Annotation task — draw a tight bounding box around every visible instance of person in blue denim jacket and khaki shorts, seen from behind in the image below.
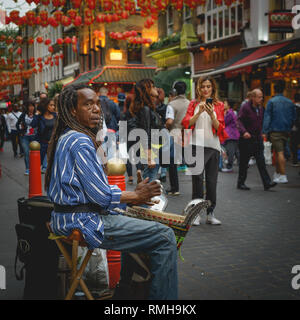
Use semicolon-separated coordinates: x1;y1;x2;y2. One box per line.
263;80;296;183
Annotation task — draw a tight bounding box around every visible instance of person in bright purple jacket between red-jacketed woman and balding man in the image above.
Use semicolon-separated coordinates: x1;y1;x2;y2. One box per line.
222;100;240;172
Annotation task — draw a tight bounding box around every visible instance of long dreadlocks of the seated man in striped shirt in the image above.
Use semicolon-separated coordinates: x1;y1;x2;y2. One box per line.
45;84;103;190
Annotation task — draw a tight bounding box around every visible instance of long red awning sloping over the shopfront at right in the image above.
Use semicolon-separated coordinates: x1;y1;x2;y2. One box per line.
194;40;299;77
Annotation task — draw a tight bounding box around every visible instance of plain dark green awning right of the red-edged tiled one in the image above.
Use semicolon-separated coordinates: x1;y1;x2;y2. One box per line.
154;67;191;96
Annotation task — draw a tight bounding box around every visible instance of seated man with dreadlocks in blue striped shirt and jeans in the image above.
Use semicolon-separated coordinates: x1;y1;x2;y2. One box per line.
45;85;177;299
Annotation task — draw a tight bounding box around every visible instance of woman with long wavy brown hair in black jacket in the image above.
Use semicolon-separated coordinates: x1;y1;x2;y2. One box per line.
129;79;164;181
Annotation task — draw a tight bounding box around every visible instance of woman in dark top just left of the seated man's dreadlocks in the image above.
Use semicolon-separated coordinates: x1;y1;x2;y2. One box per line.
31;98;56;173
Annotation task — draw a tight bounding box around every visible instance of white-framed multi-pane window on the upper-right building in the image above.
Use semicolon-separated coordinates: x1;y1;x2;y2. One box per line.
205;0;243;42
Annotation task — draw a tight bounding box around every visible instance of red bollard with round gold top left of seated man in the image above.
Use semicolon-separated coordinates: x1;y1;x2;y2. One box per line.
28;141;43;198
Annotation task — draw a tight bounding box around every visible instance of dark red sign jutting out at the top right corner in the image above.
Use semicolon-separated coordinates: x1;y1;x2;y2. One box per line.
269;12;295;33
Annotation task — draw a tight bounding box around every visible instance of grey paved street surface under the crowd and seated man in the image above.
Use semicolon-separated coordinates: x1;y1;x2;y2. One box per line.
0;143;300;300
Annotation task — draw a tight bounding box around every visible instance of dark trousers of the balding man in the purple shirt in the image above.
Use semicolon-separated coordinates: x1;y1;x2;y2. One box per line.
238;138;271;187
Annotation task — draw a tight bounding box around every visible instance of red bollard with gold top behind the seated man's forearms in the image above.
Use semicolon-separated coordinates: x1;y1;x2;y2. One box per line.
106;158;126;289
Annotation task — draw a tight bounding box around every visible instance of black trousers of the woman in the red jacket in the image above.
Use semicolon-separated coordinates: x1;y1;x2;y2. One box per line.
192;148;220;213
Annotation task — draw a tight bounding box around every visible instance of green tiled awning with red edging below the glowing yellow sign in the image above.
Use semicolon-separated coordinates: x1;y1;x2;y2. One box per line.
89;66;156;84
